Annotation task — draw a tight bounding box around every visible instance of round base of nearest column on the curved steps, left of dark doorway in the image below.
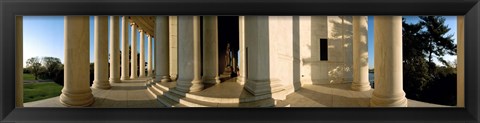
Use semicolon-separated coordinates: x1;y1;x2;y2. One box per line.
175;80;204;93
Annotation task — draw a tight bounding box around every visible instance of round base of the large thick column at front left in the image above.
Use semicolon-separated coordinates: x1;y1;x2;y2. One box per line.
60;88;95;107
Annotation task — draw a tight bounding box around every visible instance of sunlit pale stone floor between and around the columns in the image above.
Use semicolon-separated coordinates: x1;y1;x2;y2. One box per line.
24;79;450;108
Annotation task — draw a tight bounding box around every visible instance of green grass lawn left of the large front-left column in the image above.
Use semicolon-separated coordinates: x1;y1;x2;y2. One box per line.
23;82;63;103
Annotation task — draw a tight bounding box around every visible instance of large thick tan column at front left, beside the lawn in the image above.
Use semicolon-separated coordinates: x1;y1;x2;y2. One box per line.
60;16;94;106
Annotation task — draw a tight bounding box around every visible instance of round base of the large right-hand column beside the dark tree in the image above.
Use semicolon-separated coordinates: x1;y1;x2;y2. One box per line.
370;92;407;107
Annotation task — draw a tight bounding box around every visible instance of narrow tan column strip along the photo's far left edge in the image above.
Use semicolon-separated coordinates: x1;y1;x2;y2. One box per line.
15;16;23;107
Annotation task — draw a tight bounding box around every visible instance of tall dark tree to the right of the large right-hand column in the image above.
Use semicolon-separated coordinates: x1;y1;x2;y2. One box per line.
402;16;456;105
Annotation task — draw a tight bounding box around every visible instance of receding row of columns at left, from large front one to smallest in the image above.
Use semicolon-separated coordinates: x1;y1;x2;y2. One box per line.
60;16;158;106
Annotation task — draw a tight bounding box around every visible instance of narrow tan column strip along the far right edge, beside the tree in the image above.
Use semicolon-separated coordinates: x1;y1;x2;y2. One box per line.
457;16;465;107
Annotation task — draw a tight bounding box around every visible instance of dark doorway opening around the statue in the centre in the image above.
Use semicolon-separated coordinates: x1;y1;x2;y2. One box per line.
218;16;239;74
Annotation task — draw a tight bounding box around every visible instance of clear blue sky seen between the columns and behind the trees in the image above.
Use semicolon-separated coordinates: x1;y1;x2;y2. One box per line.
23;16;457;68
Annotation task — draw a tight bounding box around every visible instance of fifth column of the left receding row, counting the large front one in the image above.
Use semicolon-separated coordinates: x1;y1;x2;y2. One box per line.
130;23;138;79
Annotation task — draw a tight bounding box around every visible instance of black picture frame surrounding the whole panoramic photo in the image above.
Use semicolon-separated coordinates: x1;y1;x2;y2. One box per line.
0;0;480;122
